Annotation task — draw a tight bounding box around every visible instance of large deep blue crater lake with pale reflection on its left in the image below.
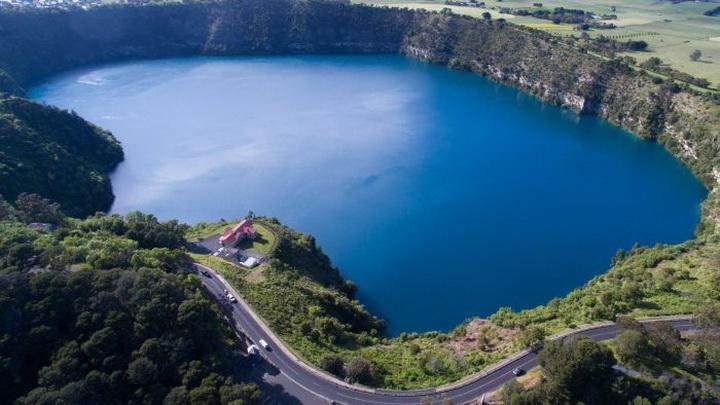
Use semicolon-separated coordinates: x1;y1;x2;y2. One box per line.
30;56;706;335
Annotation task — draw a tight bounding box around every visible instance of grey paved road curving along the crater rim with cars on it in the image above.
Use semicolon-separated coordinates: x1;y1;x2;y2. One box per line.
195;263;694;405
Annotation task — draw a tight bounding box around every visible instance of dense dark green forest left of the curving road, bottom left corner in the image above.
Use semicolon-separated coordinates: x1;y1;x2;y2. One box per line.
0;195;260;404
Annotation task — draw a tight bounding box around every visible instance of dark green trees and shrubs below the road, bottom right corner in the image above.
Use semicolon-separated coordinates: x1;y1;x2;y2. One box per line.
500;305;720;405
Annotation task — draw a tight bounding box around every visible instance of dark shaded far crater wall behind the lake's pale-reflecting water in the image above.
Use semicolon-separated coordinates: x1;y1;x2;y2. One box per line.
0;0;412;83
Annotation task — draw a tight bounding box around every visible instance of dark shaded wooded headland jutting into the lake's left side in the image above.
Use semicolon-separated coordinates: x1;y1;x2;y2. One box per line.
0;96;123;216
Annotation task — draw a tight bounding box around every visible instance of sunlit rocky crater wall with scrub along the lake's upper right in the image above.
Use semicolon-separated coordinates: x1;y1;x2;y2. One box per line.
401;13;720;188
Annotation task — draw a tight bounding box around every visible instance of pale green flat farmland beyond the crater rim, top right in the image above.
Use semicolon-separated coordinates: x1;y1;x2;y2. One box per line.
353;0;720;88
